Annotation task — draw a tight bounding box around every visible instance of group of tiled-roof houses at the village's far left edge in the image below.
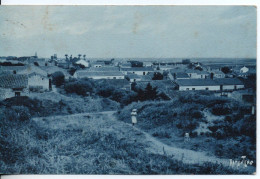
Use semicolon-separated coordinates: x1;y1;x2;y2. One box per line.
0;64;69;99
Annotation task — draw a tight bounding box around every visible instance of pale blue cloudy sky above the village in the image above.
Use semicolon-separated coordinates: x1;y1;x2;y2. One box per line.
0;6;256;58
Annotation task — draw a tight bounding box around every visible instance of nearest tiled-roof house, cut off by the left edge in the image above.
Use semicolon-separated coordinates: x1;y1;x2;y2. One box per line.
0;74;29;100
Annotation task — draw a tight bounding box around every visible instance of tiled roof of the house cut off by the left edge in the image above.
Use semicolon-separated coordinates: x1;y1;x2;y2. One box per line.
0;75;28;88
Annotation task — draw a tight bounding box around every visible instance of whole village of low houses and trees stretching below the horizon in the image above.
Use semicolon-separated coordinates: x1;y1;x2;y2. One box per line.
0;53;256;103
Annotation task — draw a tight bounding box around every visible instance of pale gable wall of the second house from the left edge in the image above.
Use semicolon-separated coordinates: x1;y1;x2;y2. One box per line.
28;75;49;90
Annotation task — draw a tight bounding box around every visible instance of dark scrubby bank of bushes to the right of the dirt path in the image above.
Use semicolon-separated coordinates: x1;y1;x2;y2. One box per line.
118;92;256;166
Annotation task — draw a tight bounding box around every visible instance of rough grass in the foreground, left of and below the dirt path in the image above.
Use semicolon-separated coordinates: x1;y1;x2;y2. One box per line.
0;107;252;174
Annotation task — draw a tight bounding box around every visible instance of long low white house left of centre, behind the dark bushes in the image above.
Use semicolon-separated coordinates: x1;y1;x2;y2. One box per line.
74;70;125;80
